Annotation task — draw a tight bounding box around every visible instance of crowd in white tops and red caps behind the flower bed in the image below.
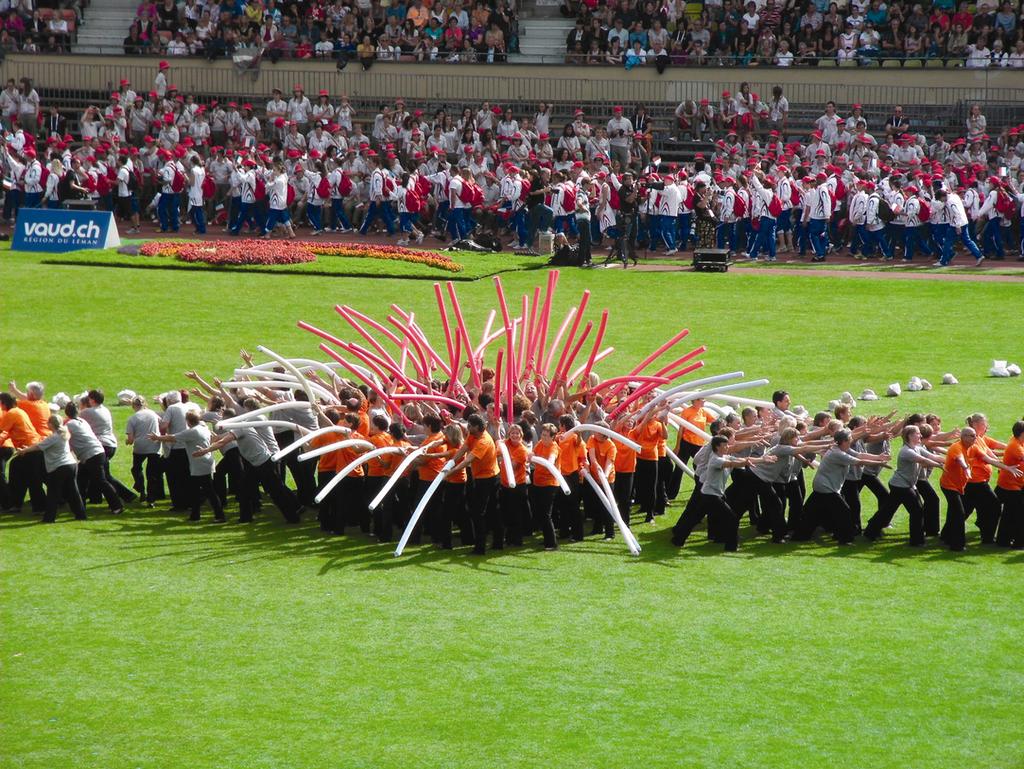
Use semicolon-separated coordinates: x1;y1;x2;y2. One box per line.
6;67;1024;266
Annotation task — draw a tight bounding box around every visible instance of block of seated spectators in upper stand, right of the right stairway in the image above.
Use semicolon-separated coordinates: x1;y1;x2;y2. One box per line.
562;0;1024;73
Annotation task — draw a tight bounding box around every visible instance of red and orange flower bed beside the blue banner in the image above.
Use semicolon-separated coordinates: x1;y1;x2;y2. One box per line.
138;240;462;272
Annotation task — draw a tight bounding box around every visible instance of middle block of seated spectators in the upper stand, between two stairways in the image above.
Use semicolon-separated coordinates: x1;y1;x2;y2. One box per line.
124;0;518;69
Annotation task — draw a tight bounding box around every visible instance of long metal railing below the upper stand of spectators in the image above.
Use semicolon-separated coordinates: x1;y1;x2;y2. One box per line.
0;54;1024;112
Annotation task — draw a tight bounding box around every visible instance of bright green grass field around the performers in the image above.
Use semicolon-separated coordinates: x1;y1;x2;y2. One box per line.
0;247;1024;769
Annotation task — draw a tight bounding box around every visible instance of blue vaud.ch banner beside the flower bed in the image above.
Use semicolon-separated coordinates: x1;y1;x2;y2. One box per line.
10;208;121;253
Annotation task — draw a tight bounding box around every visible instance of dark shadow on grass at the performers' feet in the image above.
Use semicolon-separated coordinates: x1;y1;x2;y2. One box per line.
0;506;1024;575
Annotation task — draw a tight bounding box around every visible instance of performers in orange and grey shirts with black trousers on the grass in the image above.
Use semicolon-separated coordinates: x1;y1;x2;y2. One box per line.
0;372;1024;554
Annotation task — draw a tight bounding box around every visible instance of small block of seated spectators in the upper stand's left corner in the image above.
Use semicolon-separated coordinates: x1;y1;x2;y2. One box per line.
0;0;88;53
